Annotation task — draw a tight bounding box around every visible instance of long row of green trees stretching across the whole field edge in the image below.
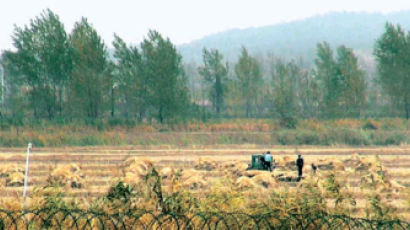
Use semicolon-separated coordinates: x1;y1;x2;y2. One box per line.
0;10;410;127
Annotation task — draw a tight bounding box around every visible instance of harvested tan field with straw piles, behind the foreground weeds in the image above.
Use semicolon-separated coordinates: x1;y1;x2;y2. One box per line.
0;146;410;219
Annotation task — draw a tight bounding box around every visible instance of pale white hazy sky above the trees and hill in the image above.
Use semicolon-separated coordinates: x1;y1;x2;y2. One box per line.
0;0;410;50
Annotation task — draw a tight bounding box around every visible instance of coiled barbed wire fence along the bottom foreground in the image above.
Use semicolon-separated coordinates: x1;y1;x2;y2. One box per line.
0;208;410;230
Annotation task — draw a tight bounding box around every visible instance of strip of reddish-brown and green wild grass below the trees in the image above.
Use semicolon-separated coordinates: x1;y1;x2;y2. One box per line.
0;118;410;147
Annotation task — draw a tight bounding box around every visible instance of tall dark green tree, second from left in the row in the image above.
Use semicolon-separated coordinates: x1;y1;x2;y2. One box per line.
70;18;111;118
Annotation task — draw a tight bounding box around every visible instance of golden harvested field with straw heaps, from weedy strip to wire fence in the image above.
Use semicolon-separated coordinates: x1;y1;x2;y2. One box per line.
0;145;410;220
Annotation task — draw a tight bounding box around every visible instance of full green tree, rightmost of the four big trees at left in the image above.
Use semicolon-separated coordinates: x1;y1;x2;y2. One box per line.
141;31;189;123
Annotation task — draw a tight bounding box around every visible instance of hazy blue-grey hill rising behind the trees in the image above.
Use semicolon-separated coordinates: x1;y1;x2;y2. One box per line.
179;11;410;62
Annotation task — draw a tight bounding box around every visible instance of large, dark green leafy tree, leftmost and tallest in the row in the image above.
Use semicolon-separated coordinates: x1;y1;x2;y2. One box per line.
10;10;72;119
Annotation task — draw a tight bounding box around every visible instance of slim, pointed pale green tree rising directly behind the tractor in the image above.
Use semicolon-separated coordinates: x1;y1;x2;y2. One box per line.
235;47;263;117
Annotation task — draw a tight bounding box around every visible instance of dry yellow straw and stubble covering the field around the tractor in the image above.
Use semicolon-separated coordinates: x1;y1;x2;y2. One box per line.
0;146;410;220
